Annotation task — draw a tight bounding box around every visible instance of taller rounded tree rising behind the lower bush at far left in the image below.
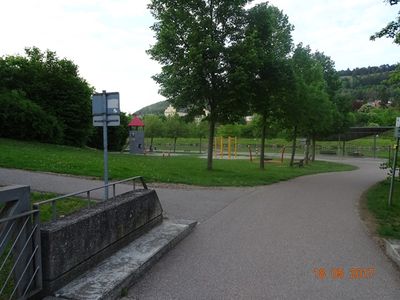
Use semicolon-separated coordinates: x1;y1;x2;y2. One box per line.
0;47;93;146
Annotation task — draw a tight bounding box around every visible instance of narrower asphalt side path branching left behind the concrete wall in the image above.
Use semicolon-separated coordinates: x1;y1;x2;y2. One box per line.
0;168;255;222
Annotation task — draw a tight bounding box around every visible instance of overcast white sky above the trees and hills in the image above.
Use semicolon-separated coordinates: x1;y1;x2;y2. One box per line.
0;0;400;112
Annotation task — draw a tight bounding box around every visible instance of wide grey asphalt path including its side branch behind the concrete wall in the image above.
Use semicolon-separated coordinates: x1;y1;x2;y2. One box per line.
0;159;400;300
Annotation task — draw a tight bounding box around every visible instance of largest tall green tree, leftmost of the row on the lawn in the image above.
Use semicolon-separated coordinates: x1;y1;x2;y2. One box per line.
148;0;250;170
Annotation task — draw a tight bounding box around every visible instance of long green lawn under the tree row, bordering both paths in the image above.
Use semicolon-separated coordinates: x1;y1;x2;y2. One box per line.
0;139;355;186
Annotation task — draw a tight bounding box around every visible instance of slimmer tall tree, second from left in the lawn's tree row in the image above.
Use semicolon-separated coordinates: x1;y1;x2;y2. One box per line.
247;3;293;169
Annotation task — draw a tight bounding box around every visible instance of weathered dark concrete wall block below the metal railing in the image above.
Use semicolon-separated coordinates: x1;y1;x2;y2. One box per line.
41;190;162;281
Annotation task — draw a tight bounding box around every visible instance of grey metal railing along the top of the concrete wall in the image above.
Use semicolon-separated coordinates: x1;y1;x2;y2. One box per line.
33;176;147;220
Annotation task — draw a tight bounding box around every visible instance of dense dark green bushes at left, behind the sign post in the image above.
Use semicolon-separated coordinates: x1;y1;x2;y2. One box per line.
0;47;129;150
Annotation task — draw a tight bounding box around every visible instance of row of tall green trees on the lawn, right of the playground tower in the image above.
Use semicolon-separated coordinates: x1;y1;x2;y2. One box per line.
148;0;351;169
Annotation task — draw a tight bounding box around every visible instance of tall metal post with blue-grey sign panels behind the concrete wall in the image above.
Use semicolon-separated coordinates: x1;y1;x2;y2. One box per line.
92;91;120;200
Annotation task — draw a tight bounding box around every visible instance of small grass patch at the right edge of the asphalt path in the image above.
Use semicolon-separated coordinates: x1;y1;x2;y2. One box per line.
367;180;400;239
